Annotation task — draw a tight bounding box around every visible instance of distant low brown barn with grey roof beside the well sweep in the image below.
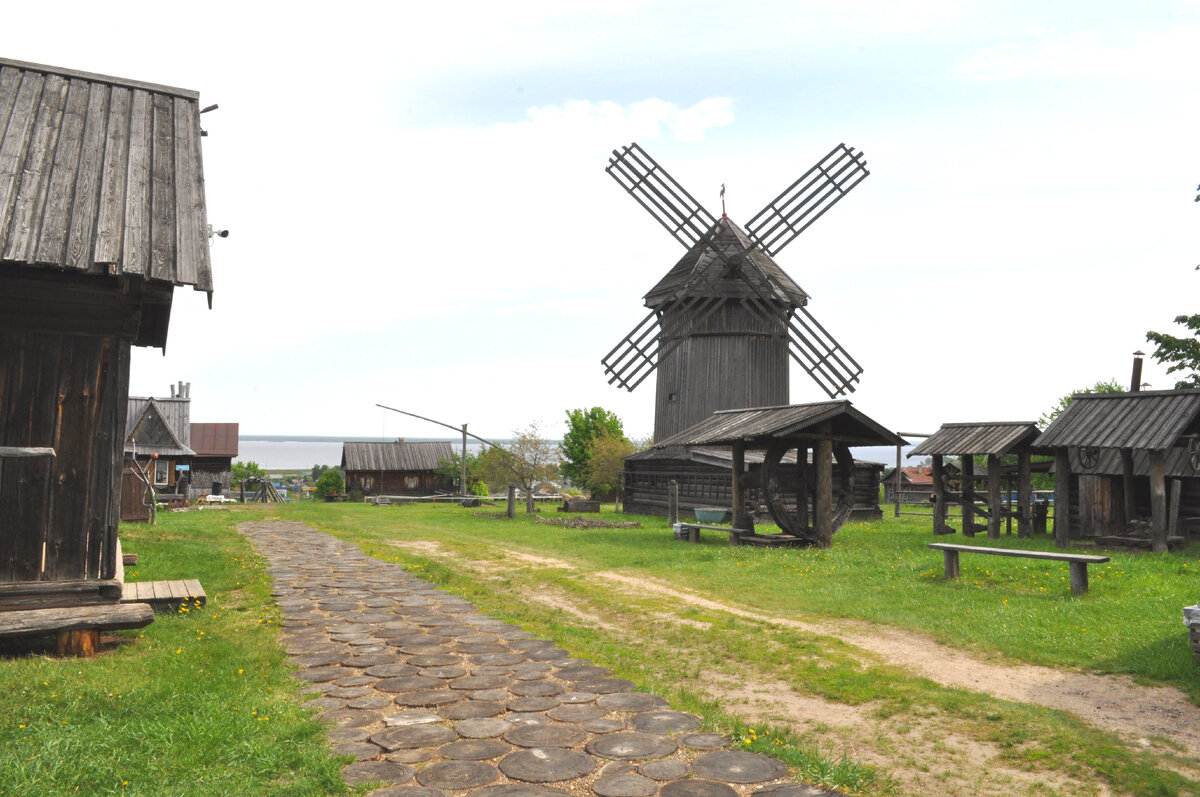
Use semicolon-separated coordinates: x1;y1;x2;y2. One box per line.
342;441;454;496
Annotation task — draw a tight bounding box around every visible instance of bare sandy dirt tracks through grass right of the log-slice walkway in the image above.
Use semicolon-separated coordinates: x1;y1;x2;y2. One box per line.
395;540;1200;795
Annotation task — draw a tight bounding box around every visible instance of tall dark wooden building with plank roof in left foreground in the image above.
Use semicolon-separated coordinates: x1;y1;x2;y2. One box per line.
0;60;212;648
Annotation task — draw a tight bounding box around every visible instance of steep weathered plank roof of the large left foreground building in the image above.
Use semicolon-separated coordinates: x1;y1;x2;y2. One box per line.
0;59;212;296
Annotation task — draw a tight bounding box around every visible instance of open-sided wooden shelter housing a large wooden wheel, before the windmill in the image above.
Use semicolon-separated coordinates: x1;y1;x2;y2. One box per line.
643;400;905;547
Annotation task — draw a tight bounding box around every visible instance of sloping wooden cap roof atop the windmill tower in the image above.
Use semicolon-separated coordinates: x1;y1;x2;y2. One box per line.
646;218;809;307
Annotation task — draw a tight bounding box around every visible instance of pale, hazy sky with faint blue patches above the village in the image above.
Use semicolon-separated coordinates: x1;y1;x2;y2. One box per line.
0;0;1200;438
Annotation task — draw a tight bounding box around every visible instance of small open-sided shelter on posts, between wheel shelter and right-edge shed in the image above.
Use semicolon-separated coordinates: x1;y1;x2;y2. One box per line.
908;421;1038;538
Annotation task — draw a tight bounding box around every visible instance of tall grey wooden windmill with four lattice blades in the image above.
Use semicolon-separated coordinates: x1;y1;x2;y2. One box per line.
601;143;870;441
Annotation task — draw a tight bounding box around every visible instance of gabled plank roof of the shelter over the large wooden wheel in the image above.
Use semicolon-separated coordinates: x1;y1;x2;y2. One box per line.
654;400;905;448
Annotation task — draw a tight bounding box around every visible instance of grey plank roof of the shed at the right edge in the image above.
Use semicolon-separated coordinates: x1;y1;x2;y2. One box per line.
1037;390;1200;451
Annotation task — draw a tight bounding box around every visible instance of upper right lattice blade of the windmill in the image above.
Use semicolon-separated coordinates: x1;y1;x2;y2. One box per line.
745;144;870;257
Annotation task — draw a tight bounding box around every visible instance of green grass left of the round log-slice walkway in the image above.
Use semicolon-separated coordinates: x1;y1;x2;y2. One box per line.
0;510;346;795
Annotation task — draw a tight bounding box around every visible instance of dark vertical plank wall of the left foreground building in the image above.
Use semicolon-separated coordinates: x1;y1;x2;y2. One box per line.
0;330;130;582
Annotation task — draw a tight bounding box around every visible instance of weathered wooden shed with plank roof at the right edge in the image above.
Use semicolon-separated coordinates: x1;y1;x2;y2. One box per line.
1037;390;1200;552
